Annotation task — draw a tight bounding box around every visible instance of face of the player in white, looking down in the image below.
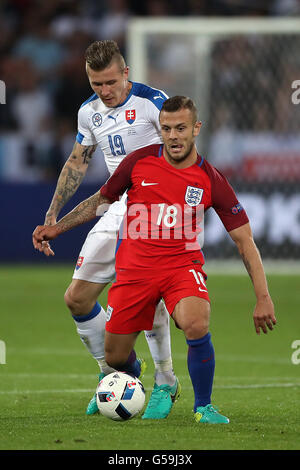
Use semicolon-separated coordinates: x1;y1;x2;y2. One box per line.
86;62;128;108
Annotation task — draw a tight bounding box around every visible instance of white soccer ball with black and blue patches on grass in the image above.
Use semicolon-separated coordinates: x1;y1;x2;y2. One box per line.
96;372;145;421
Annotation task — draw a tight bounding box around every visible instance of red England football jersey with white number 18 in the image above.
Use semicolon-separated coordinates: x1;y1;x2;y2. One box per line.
100;145;248;270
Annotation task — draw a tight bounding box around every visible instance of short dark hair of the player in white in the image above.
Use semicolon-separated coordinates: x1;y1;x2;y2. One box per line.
84;40;126;71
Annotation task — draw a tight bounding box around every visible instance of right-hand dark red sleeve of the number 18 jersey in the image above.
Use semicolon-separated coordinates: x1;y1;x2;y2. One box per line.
206;162;249;232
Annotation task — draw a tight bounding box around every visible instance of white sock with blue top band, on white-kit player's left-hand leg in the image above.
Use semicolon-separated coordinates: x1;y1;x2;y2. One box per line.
72;302;115;375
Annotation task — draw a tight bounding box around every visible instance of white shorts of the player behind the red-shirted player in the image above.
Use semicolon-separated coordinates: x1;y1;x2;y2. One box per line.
73;194;127;284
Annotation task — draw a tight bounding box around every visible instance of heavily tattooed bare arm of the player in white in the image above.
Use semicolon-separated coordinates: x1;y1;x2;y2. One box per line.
45;142;97;225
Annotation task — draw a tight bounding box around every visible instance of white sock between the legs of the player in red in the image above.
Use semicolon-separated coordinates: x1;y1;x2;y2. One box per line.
145;301;176;386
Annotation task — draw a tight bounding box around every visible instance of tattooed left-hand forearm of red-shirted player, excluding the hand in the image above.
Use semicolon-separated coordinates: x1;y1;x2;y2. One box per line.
55;191;110;233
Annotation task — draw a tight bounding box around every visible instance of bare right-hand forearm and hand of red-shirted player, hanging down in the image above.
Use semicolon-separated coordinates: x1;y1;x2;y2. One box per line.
229;224;276;334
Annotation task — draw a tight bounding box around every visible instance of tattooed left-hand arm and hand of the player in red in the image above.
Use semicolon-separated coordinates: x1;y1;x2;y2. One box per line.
32;191;111;251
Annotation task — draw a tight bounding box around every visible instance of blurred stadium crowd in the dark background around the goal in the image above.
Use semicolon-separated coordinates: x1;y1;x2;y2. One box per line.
0;0;300;182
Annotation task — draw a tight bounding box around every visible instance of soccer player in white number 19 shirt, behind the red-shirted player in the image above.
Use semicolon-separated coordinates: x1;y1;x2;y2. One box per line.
43;40;180;419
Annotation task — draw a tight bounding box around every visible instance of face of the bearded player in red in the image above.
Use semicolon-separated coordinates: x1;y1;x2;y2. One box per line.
160;109;201;163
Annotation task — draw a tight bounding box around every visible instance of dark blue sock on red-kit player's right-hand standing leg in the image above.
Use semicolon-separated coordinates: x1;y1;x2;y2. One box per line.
186;333;215;412
